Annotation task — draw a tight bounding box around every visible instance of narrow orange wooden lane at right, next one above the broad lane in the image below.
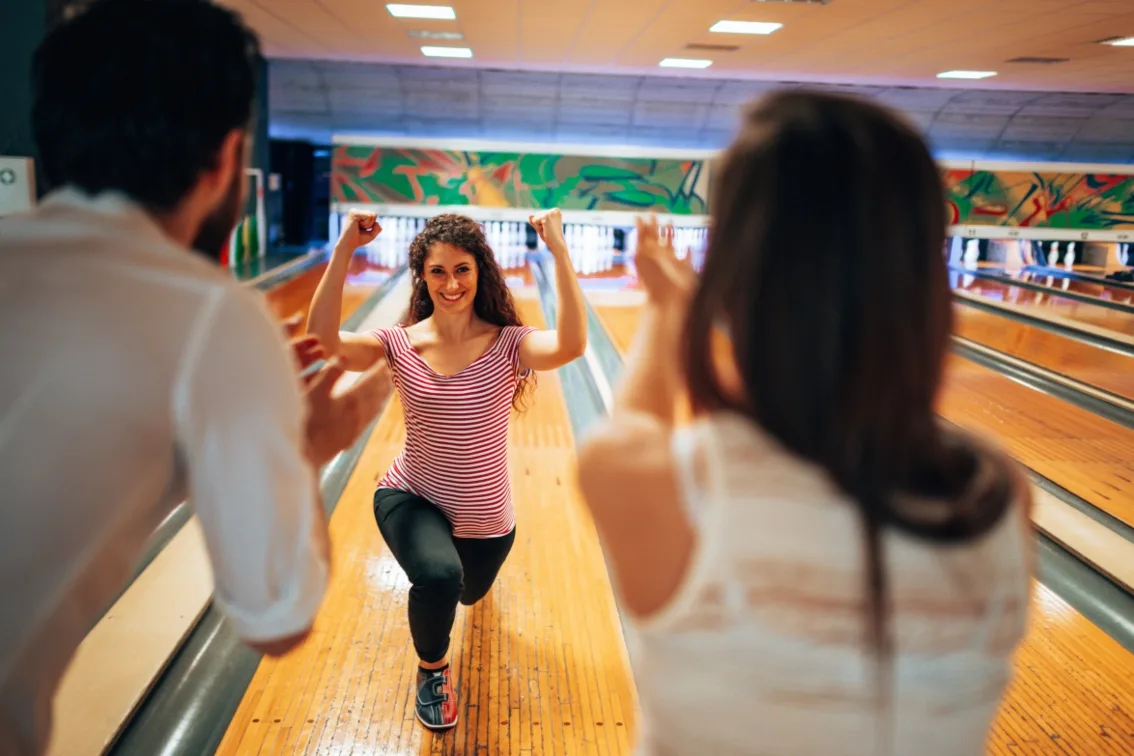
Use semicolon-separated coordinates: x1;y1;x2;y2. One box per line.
954;305;1134;399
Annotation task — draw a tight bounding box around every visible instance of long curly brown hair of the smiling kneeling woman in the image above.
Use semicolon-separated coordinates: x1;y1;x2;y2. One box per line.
401;213;536;411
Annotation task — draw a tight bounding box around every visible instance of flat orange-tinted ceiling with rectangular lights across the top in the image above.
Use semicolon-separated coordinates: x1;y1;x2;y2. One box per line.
221;0;1134;94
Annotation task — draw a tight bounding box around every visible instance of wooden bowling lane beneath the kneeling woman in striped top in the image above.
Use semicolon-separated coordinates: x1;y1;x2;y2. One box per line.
218;298;636;756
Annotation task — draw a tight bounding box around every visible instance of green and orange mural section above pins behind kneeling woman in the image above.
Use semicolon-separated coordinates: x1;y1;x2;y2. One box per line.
331;145;709;215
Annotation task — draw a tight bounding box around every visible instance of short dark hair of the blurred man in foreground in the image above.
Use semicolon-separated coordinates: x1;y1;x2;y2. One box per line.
32;0;260;211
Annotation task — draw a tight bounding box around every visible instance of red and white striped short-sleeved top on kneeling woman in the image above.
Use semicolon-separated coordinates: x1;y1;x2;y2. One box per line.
374;325;536;538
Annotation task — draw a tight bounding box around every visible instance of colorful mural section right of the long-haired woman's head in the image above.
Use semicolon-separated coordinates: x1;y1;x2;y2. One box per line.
942;169;1134;231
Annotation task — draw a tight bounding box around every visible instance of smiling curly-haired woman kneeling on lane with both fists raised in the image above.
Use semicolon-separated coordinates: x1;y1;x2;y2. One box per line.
307;210;586;730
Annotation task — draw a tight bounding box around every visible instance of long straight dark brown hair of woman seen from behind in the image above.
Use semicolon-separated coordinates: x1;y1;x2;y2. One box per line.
684;91;1008;720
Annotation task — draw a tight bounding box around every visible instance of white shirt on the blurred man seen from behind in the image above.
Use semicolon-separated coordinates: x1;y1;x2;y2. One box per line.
0;185;328;754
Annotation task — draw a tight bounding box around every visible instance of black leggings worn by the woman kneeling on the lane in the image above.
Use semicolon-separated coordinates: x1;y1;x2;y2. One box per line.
374;489;516;663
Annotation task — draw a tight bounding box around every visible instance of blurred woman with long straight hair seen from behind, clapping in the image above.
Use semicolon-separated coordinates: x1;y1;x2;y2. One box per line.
579;92;1032;756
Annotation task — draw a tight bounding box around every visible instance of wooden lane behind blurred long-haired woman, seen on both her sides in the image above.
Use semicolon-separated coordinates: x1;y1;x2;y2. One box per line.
592;299;1134;756
